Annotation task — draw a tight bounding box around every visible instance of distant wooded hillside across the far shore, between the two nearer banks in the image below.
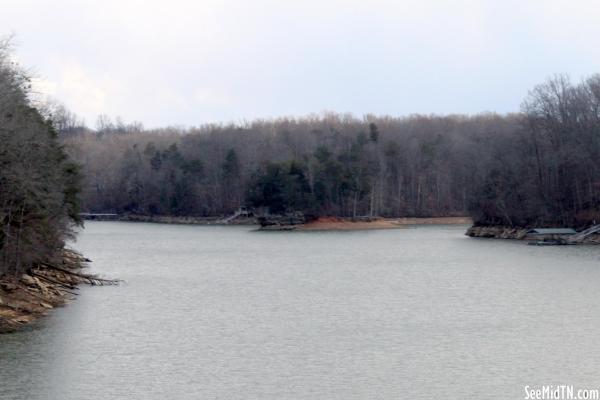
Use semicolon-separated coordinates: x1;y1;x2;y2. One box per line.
65;114;518;216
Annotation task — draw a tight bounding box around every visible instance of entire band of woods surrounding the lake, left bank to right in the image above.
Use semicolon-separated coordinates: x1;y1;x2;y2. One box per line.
0;37;600;274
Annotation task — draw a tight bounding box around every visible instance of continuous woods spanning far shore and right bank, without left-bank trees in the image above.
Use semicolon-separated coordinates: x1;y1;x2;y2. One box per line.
61;76;600;226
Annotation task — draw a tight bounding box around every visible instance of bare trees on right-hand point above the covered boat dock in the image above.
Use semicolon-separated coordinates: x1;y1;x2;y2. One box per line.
470;75;600;227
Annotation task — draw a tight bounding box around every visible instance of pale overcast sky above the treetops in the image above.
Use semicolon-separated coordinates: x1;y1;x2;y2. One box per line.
0;0;600;127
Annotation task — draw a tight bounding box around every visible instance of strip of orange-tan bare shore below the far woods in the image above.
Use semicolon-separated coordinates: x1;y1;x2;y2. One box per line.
296;217;473;231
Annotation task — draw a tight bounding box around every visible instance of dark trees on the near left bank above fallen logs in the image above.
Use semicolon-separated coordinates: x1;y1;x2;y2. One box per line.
0;42;80;276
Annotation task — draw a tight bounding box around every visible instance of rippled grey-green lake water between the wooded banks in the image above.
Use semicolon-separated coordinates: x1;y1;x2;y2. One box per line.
0;222;600;400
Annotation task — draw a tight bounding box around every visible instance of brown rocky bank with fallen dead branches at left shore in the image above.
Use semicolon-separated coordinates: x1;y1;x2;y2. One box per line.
0;250;117;333
